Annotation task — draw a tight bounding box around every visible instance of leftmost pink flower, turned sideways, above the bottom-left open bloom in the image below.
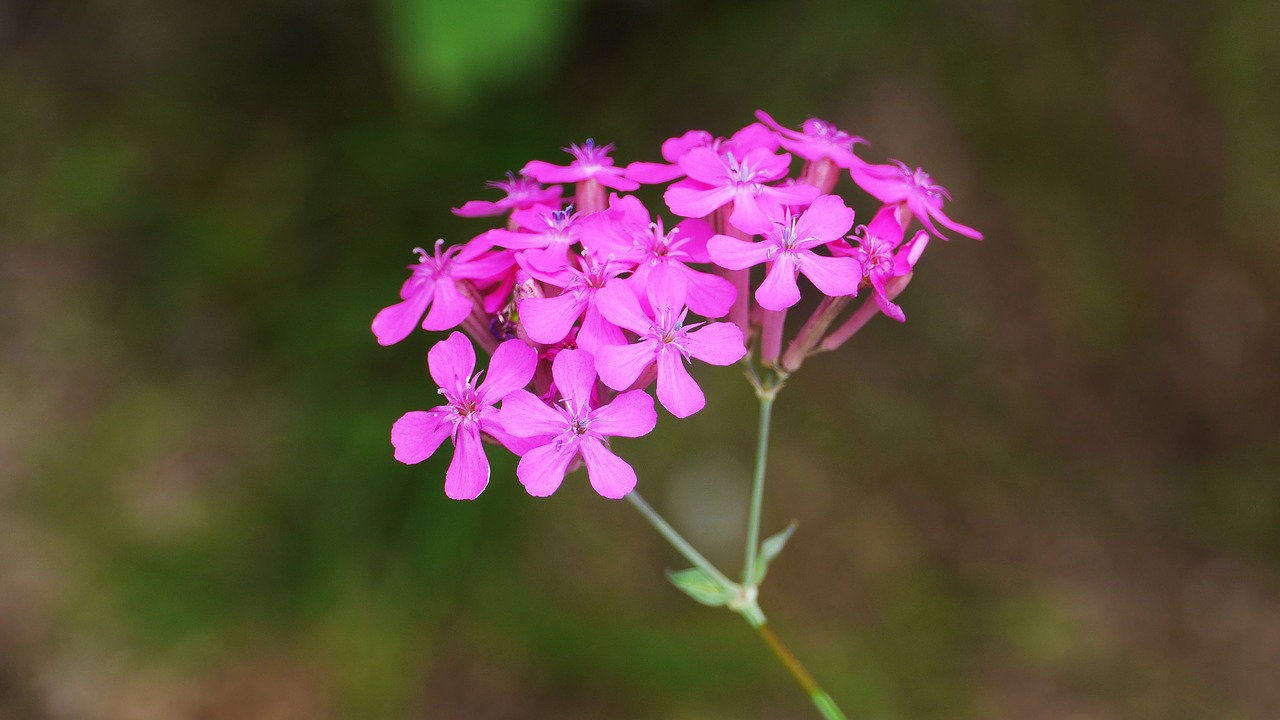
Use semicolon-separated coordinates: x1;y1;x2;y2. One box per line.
372;240;511;345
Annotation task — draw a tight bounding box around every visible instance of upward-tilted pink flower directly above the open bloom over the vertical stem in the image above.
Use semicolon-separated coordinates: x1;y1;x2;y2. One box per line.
663;142;818;226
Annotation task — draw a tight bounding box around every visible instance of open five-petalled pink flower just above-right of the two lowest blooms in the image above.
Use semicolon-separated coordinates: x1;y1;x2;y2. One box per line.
595;273;746;418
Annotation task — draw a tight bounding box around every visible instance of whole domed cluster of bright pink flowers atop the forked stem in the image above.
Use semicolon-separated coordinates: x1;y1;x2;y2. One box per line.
372;111;982;500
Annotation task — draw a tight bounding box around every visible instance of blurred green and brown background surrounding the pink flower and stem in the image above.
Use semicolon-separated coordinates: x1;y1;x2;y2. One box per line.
0;0;1280;720
